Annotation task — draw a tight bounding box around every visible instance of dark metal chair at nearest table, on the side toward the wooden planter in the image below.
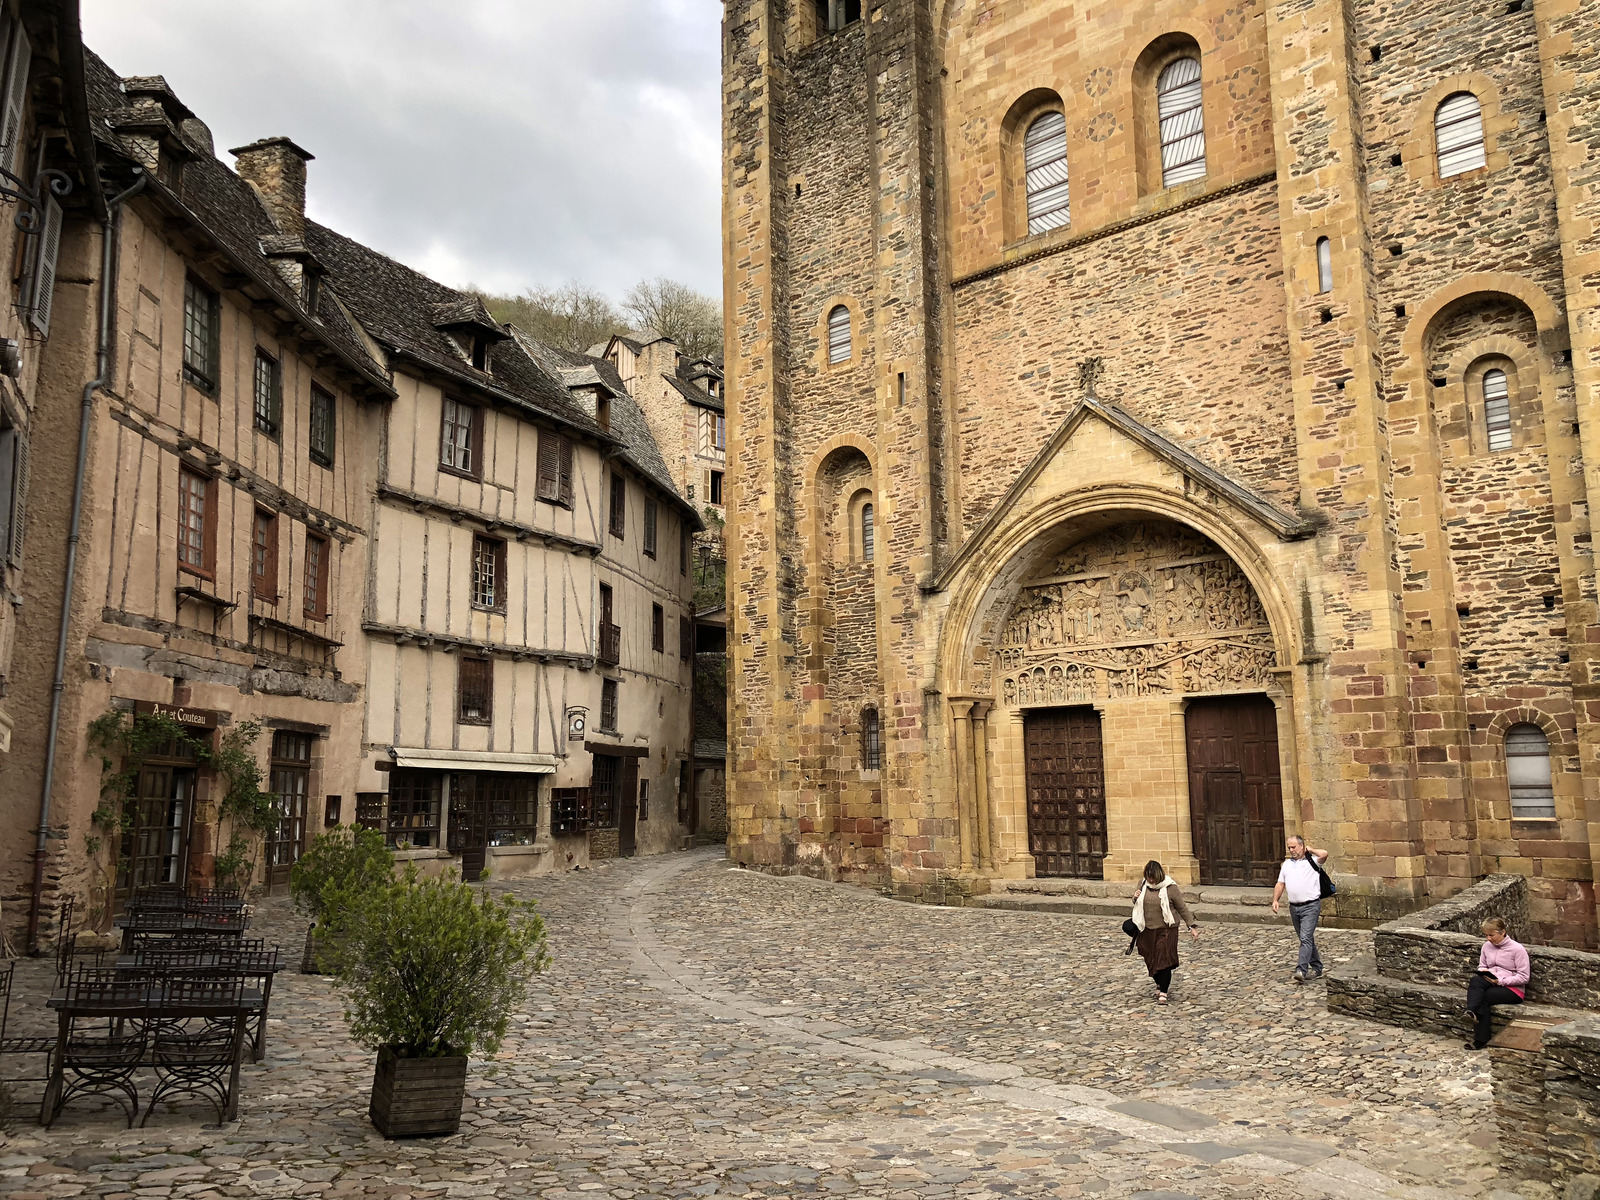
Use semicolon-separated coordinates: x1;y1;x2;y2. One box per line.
139;974;245;1126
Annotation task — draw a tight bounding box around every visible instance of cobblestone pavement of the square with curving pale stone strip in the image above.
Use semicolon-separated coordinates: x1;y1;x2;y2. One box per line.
0;851;1549;1200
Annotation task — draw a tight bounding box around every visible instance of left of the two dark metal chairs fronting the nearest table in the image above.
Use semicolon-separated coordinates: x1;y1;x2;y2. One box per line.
42;966;157;1128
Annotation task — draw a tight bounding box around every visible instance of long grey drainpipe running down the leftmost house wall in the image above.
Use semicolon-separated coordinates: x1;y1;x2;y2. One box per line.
27;166;150;954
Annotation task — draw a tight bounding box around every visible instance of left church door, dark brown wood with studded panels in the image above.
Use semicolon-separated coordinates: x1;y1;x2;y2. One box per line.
1022;709;1106;878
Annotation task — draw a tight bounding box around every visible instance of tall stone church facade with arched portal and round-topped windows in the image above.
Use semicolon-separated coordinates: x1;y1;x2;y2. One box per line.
723;0;1600;946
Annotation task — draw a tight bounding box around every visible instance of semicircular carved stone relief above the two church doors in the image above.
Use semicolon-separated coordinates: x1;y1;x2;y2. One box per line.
995;522;1277;706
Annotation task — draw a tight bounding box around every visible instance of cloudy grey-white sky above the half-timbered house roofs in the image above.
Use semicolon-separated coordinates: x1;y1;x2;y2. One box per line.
82;0;722;298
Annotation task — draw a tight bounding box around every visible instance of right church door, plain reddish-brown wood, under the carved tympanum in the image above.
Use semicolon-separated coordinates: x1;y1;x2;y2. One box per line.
1184;696;1283;886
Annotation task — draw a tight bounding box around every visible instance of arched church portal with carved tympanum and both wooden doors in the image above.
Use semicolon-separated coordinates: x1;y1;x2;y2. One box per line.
987;512;1293;885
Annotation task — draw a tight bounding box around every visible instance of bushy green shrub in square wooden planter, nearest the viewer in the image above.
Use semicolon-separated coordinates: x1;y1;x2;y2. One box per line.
318;867;550;1138
